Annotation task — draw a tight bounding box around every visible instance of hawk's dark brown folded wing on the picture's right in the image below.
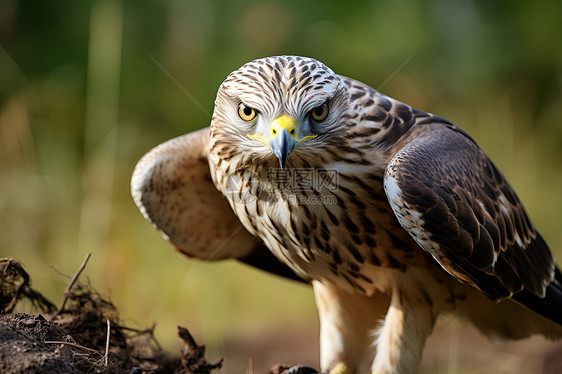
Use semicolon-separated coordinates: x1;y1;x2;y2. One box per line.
385;123;552;306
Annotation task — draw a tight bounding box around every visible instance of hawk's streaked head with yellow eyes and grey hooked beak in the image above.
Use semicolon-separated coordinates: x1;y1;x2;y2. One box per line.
211;56;350;169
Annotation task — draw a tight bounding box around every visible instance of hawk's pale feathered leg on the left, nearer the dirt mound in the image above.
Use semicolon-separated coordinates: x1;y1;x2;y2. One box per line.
312;281;389;374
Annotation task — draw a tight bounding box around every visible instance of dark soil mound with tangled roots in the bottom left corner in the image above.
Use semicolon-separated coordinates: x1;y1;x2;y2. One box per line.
0;257;222;374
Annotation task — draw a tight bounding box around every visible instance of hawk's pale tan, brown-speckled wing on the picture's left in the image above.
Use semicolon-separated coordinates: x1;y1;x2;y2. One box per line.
131;128;300;280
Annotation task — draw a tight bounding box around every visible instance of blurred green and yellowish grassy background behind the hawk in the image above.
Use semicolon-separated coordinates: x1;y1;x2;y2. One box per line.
0;0;562;373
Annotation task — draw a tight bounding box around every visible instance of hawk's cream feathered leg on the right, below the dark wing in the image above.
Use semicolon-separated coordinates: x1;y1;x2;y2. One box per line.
372;288;436;374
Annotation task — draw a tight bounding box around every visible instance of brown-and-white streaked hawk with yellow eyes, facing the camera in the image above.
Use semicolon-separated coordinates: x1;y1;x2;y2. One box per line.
132;56;562;374
